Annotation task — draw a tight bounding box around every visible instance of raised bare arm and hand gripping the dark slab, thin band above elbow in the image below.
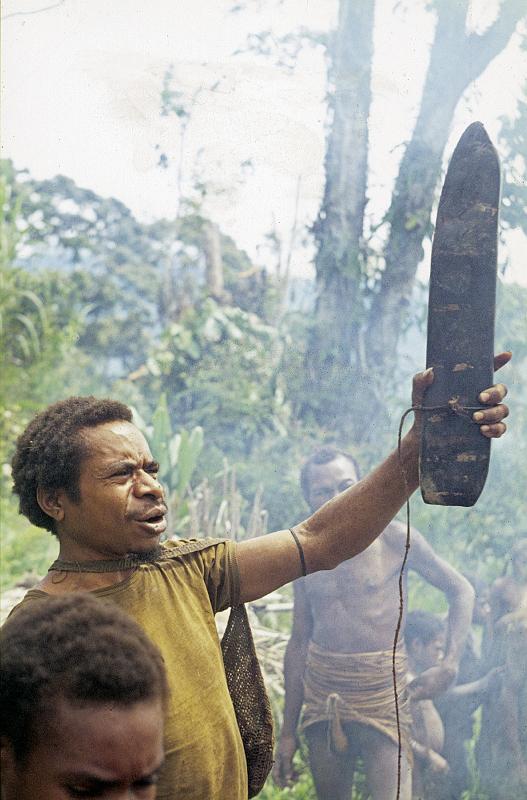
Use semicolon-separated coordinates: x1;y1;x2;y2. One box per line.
238;354;510;602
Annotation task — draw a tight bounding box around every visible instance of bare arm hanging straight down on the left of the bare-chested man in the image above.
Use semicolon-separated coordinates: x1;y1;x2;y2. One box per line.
273;581;313;786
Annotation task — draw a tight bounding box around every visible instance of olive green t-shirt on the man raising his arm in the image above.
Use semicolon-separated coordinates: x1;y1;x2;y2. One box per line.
16;540;248;800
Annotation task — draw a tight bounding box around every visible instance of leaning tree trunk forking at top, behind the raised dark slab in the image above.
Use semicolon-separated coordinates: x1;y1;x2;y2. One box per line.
367;0;526;374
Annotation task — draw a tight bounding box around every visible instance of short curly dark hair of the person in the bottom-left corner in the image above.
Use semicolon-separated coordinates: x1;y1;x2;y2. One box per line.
0;593;168;763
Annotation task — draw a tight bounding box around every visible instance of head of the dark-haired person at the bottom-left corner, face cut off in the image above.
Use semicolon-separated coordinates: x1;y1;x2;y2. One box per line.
0;594;167;800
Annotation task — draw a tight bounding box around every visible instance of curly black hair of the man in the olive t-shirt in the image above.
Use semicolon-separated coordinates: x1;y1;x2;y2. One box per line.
12;396;132;533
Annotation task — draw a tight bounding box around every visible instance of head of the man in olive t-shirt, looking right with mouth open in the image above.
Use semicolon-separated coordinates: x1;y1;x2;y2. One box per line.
13;397;166;561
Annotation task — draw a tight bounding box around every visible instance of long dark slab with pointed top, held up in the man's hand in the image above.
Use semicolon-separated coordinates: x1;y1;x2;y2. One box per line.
419;122;500;506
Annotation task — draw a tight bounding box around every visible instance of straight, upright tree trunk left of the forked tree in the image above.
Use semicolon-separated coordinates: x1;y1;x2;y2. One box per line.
307;0;375;438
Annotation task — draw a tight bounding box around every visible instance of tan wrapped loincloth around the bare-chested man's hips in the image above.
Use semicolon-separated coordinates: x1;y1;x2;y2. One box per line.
302;642;412;763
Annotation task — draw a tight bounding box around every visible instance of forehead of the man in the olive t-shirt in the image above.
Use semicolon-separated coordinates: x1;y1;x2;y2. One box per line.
79;420;152;461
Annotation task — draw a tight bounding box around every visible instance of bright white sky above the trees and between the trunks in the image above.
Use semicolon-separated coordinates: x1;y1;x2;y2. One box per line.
2;0;527;283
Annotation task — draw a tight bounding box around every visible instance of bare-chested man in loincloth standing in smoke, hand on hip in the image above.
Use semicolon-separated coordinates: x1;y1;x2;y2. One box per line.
274;447;474;800
